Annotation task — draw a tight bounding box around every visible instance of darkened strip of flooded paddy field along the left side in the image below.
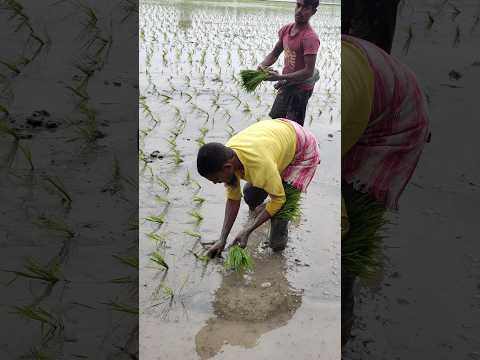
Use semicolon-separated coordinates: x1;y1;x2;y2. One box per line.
0;0;138;359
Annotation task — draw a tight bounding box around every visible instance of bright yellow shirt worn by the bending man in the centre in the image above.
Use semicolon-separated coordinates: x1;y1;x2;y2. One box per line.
225;120;297;216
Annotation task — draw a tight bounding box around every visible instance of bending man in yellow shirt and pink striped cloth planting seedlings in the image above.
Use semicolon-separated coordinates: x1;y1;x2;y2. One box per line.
197;119;320;257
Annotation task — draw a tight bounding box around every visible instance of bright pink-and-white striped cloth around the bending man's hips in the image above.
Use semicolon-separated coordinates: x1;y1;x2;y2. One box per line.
279;119;320;192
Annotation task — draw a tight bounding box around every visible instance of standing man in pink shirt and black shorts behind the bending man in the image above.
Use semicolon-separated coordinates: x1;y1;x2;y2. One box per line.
258;0;320;126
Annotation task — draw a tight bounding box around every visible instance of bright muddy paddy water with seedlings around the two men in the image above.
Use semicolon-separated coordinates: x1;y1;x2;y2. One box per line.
139;1;340;359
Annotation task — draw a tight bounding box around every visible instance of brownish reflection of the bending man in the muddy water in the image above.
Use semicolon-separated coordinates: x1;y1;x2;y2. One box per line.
195;228;302;359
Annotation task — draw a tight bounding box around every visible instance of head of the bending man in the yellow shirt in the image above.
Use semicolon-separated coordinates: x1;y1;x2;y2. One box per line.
197;142;238;185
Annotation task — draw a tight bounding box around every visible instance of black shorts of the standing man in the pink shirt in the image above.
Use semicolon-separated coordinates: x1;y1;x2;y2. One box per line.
268;86;313;126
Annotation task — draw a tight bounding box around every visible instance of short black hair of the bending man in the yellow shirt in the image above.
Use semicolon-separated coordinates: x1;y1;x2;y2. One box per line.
197;142;233;177
